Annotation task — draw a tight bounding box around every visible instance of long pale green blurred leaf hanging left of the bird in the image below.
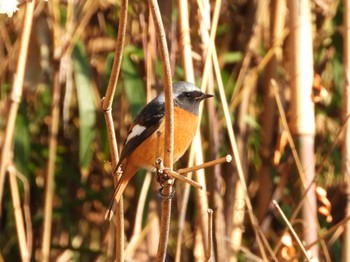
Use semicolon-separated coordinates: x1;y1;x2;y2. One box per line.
73;42;96;168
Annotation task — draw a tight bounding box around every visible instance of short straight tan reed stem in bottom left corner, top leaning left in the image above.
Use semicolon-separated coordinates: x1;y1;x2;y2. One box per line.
8;166;30;262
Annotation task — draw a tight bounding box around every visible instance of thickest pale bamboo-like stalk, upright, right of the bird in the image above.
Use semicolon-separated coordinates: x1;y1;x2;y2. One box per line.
287;0;319;259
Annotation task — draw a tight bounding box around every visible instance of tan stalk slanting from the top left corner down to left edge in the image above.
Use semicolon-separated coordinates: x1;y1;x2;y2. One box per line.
0;0;35;211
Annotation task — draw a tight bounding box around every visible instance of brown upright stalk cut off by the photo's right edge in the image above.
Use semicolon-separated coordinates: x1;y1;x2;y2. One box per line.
342;0;350;261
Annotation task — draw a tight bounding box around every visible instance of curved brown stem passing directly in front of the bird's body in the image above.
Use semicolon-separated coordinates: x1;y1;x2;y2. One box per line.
149;0;174;261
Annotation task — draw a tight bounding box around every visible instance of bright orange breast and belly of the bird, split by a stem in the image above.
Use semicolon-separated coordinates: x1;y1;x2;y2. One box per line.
127;107;198;168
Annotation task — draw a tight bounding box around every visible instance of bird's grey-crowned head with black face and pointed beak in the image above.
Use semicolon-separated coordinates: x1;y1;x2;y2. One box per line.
173;82;213;115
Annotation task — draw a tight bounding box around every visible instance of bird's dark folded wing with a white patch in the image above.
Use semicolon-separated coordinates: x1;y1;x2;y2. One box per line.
117;99;165;169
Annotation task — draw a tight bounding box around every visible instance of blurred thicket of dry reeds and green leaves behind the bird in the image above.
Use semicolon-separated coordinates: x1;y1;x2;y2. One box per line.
0;0;350;261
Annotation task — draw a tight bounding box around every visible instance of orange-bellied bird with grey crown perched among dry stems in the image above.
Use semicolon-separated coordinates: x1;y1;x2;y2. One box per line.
109;81;213;210
